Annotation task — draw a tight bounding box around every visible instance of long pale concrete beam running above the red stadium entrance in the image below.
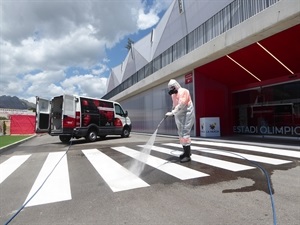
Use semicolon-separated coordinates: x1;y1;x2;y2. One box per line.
110;0;300;102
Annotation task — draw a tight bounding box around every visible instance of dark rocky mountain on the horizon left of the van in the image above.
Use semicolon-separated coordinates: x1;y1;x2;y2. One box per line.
0;95;35;109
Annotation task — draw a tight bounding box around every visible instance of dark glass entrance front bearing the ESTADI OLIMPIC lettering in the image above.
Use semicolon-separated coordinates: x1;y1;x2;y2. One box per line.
233;81;300;137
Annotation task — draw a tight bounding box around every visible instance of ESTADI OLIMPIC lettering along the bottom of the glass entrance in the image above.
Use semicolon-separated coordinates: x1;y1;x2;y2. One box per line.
233;126;300;136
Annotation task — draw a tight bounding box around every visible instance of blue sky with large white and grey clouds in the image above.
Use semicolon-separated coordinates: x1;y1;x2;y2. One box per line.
0;0;172;103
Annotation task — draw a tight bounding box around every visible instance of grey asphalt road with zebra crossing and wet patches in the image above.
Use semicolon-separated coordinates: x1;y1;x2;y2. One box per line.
0;134;300;225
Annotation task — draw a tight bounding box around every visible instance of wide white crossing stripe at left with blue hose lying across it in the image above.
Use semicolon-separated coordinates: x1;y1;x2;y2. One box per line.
25;152;72;207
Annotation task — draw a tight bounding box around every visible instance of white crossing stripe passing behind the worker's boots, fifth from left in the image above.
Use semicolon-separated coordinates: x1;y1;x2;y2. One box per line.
147;146;255;172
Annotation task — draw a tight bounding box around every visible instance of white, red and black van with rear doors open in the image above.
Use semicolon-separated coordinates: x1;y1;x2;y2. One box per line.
36;95;131;143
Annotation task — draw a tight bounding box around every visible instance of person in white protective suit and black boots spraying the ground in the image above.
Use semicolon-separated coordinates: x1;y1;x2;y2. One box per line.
166;79;195;163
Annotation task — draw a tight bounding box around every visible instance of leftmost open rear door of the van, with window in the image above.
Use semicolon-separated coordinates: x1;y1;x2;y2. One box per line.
35;97;51;133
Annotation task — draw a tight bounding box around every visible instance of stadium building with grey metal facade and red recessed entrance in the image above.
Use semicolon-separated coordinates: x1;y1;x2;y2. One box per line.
104;0;300;138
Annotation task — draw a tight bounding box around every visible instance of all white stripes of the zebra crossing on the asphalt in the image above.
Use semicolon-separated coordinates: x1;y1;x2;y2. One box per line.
0;141;300;207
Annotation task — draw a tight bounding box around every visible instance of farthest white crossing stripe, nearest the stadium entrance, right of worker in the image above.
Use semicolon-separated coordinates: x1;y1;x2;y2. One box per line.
192;141;300;158
